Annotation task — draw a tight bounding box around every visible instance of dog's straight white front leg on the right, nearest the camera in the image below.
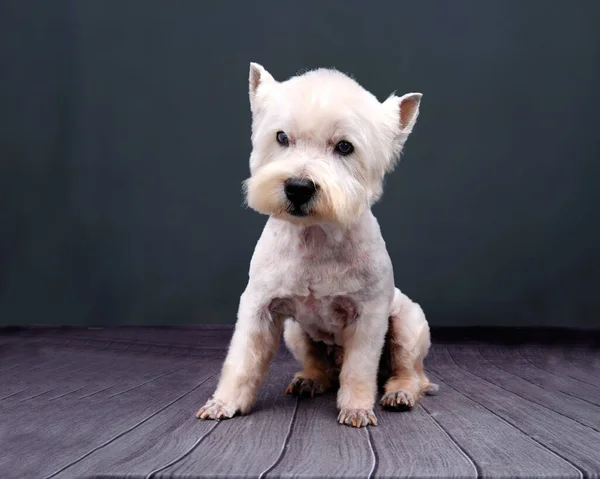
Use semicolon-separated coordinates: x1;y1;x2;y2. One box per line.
337;304;389;427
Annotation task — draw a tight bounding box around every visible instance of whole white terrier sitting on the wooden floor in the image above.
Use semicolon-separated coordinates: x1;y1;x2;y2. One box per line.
197;63;437;427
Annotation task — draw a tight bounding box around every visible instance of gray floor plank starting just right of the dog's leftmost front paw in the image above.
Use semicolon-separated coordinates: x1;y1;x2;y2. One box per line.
152;361;297;478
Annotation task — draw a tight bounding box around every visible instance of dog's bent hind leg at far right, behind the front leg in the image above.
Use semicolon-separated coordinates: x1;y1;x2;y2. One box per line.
381;289;438;410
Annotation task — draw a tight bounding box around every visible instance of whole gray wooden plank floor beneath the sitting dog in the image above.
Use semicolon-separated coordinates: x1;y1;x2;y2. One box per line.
0;328;600;479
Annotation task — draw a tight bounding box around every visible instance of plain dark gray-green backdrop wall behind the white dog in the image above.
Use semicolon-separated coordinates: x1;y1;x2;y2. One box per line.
0;0;600;327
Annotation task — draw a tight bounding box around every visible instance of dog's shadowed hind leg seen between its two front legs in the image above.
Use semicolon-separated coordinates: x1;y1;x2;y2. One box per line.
283;319;333;396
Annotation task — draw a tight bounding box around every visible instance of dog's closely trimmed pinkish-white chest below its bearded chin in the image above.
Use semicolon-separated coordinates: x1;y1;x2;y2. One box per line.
255;221;378;345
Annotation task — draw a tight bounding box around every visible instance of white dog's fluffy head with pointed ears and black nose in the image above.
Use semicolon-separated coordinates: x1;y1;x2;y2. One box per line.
245;63;421;225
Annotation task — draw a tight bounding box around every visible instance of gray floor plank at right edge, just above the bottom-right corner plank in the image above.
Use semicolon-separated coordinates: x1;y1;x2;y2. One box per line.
449;347;600;432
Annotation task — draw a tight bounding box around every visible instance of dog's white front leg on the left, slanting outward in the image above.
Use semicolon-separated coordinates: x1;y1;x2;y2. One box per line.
197;288;282;419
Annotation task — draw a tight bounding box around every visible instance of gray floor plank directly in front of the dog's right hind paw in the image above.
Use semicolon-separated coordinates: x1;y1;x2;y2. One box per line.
369;407;477;478
